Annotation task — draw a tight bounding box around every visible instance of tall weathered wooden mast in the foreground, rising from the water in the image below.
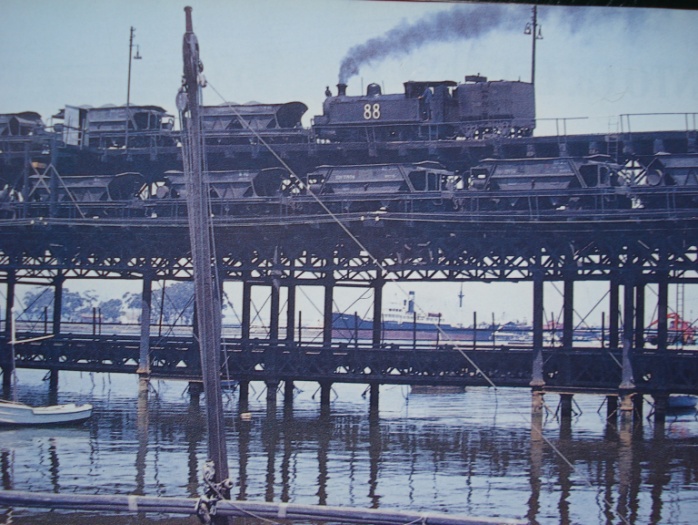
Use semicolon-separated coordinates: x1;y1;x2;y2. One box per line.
177;7;230;502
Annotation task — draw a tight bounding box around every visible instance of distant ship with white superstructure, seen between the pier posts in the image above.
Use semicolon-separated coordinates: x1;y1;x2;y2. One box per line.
332;292;497;344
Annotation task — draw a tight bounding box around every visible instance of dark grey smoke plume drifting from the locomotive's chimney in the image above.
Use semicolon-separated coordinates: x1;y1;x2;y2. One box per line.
339;5;528;84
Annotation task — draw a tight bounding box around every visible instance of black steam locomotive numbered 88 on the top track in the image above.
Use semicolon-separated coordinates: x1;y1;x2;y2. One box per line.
313;75;535;142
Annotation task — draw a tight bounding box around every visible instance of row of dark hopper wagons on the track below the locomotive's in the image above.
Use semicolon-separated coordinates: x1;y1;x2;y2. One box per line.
5;154;698;218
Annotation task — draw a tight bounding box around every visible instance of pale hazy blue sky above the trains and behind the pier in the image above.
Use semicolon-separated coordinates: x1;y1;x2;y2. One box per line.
0;0;698;321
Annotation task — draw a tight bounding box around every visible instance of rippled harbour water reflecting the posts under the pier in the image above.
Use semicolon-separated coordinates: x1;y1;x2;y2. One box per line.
0;371;698;525
